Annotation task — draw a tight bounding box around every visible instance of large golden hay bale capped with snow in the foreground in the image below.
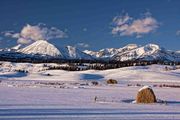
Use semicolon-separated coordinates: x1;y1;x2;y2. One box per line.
136;86;157;103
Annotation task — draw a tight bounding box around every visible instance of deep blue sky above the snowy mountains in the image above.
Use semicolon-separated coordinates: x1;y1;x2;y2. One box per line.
0;0;180;50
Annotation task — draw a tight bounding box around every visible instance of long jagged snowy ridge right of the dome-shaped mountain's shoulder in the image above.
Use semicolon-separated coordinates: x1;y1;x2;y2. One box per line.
84;44;180;61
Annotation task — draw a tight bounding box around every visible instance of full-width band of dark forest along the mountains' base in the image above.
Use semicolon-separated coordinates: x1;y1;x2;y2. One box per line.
0;53;180;71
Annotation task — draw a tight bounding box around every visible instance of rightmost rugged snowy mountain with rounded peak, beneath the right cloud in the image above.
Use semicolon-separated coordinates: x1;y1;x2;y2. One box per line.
112;44;180;61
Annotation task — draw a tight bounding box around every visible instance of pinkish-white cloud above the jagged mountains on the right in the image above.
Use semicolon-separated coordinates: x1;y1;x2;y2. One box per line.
112;13;159;38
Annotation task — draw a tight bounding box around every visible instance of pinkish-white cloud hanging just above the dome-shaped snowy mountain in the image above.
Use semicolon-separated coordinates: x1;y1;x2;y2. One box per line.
4;24;67;44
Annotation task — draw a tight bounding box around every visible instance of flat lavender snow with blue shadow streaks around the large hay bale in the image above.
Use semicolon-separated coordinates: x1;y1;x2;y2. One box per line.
0;83;180;120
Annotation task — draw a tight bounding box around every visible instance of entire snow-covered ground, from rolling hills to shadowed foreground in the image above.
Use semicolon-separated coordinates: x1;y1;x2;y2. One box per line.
0;62;180;120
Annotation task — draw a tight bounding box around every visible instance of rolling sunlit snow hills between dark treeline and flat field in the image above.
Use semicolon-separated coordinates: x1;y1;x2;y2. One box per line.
0;62;180;83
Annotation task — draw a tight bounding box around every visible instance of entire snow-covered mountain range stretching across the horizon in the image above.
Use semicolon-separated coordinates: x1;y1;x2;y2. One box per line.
0;40;180;62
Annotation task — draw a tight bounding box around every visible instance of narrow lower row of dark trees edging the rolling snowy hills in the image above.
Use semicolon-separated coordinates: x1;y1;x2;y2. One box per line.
43;61;179;71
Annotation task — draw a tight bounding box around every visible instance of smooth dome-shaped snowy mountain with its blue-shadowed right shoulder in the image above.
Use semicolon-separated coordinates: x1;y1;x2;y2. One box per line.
17;40;92;60
